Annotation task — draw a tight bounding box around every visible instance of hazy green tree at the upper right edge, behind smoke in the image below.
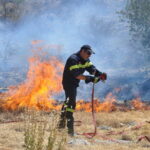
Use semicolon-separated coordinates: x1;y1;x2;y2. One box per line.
120;0;150;56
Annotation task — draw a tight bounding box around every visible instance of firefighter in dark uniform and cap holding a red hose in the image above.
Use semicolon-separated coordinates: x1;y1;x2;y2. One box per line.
58;45;107;136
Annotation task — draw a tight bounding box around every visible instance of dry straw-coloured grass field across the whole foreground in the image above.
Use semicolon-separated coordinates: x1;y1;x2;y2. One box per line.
0;111;150;150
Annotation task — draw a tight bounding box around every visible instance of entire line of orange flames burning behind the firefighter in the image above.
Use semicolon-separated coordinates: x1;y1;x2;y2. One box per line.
0;40;150;112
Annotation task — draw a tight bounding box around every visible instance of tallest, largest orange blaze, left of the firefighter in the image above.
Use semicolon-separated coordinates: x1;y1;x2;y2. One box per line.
3;57;63;110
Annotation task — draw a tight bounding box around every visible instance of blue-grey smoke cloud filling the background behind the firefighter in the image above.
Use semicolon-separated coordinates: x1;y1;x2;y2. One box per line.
0;0;149;99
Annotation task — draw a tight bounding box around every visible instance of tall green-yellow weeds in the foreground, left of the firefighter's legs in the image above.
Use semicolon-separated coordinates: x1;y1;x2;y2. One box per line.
24;110;66;150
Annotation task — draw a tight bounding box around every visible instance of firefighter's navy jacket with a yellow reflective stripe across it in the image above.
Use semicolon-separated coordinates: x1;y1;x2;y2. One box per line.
62;52;100;88
